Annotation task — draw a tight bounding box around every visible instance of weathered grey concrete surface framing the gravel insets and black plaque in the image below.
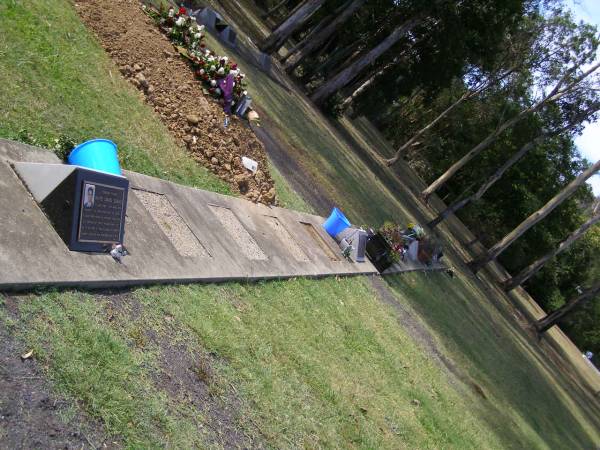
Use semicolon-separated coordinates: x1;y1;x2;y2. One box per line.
0;140;377;290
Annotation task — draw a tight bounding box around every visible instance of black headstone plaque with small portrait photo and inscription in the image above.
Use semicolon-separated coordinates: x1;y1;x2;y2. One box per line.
42;167;129;252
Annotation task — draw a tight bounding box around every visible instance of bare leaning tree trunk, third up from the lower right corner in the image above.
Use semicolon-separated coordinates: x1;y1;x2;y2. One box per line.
469;160;600;272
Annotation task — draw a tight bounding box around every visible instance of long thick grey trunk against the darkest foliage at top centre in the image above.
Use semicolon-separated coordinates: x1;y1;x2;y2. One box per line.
310;18;420;105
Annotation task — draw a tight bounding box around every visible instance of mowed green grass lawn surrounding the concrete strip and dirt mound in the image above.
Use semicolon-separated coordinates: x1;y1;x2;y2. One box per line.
0;0;600;449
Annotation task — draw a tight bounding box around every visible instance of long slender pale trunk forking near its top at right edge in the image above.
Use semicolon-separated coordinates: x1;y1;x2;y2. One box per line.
421;63;600;200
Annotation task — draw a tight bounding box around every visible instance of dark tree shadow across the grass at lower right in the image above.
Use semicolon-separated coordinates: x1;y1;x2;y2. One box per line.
386;274;595;448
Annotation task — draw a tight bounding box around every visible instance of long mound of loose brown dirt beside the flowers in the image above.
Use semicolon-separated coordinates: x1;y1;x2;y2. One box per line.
75;0;277;204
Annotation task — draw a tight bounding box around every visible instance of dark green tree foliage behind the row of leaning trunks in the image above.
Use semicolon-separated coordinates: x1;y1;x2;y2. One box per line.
258;0;600;353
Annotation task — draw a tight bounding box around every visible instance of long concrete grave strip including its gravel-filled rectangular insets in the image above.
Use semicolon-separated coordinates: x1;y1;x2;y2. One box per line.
0;140;377;290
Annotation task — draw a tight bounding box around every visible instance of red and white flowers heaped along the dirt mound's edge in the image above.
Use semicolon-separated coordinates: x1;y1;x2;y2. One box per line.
142;5;248;108
